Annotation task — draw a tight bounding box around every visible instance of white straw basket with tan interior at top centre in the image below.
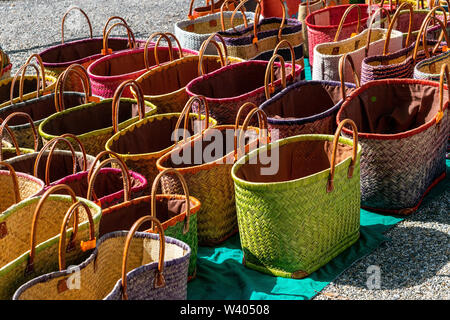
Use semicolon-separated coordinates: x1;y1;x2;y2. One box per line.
174;11;255;55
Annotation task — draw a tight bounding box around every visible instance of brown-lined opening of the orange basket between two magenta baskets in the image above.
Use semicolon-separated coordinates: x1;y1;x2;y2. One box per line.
138;56;225;95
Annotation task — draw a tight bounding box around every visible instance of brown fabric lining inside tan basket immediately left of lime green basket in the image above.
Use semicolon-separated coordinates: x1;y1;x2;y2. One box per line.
161;128;258;168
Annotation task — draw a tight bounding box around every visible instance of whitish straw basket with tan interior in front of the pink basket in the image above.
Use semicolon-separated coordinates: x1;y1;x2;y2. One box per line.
312;28;403;82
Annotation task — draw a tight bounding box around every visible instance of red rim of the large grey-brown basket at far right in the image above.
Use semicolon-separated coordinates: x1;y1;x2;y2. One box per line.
336;79;449;140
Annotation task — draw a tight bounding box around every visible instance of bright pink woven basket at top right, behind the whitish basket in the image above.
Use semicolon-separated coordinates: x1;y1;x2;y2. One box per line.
305;4;377;65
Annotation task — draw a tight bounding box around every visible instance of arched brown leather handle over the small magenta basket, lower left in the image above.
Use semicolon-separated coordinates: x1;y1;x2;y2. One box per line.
86;150;131;203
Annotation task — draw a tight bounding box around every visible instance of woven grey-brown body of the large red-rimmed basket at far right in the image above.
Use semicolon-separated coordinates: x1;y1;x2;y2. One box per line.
337;80;450;215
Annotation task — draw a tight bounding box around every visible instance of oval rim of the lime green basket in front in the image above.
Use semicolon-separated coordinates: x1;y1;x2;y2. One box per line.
231;134;362;190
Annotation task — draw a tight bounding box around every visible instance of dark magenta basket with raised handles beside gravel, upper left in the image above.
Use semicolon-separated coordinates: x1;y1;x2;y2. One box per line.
39;6;145;91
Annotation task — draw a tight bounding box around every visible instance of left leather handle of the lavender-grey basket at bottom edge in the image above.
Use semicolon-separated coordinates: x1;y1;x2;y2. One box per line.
58;201;96;271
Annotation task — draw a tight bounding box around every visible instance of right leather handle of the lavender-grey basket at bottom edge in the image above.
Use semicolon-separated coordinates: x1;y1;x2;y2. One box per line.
122;216;166;300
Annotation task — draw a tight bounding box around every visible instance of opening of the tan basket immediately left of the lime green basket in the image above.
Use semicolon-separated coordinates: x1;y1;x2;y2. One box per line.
161;126;258;168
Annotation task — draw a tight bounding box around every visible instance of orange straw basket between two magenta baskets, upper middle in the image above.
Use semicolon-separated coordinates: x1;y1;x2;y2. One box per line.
132;32;243;114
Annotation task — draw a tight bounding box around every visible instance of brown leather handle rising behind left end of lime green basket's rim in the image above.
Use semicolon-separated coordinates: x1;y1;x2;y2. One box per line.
234;102;270;161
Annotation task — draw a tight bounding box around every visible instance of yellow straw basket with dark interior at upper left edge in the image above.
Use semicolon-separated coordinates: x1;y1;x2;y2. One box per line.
0;74;56;109
